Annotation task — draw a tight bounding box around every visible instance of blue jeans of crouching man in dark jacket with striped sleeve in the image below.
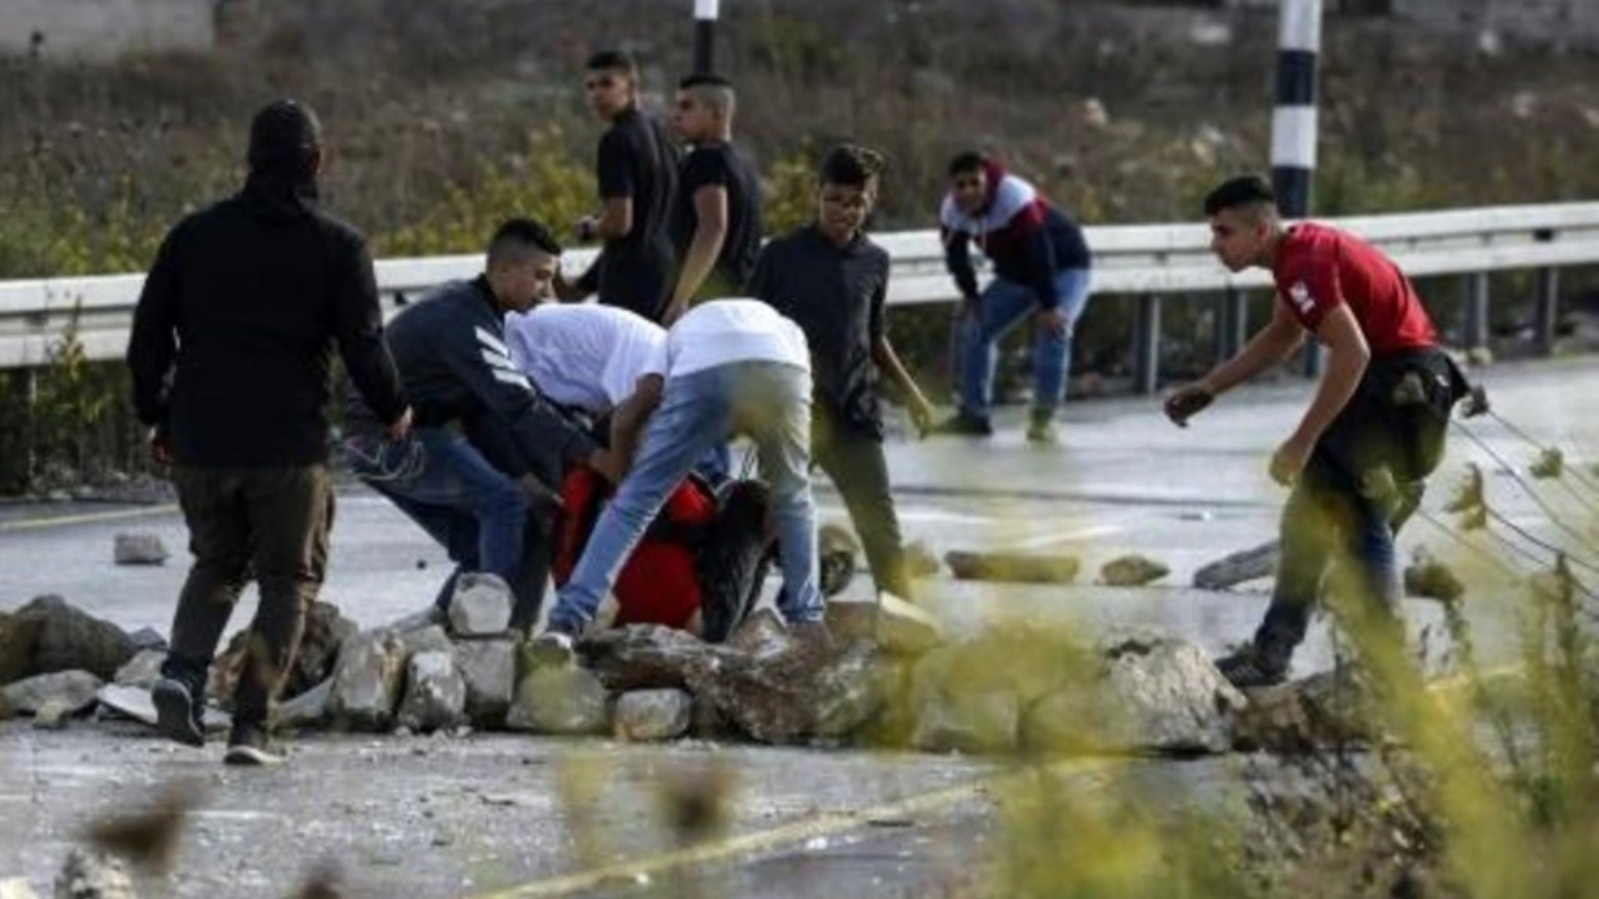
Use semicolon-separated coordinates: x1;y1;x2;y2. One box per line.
344;427;552;627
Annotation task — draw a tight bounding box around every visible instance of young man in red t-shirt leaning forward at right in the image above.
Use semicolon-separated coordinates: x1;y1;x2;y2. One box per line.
1166;176;1466;686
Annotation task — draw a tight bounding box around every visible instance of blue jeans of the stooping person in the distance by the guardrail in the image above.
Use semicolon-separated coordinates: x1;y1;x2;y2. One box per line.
955;269;1089;418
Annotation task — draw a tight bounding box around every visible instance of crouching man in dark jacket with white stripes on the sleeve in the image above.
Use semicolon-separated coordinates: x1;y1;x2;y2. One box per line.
344;219;619;630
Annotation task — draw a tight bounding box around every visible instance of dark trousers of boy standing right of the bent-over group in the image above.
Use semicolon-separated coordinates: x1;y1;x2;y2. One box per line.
811;429;913;600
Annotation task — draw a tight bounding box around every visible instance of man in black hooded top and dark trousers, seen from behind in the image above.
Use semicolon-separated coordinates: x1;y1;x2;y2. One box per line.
128;101;411;765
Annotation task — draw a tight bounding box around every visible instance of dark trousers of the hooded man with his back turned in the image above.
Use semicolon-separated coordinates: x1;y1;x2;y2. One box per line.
173;465;333;725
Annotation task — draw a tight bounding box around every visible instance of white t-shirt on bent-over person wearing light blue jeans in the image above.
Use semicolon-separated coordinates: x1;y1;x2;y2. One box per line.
652;299;811;378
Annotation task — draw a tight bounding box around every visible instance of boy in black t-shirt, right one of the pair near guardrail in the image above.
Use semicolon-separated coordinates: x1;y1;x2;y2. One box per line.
662;75;761;325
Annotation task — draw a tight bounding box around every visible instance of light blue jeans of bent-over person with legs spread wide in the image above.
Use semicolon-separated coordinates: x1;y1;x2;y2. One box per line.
550;362;822;633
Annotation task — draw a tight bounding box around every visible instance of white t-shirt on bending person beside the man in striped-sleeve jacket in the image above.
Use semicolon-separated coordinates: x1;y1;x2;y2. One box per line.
505;302;667;416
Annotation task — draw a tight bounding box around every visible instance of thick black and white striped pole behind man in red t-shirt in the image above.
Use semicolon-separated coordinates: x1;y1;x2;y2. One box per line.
1271;0;1322;378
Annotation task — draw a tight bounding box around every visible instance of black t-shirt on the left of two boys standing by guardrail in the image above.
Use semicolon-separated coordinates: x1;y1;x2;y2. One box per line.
584;109;678;318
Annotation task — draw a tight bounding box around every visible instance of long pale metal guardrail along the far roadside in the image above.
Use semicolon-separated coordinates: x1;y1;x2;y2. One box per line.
0;203;1599;392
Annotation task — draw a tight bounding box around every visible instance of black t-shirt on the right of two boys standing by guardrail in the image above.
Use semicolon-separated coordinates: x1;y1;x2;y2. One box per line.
670;144;761;299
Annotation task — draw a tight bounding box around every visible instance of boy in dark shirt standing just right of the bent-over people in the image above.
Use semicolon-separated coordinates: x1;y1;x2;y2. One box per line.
748;144;932;600
